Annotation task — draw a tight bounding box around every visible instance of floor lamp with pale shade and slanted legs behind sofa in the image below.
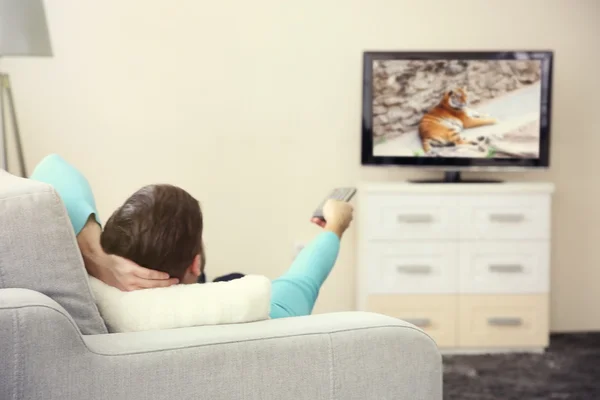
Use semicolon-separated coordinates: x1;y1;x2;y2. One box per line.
0;0;52;177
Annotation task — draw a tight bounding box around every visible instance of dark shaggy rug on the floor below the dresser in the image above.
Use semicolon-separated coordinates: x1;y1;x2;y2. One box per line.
444;333;600;400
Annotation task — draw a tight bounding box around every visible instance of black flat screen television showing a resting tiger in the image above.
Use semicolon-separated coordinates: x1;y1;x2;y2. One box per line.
362;51;553;181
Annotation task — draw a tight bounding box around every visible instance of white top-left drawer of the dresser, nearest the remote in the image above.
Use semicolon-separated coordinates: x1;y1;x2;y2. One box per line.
362;194;459;240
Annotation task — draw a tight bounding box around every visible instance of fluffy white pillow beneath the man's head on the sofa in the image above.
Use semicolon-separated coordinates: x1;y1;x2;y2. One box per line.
90;275;271;332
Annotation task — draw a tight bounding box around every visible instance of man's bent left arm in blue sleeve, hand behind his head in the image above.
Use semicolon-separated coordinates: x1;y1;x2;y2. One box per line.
31;154;177;290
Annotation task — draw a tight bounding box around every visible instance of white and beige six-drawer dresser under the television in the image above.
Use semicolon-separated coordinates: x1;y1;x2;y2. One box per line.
357;183;553;352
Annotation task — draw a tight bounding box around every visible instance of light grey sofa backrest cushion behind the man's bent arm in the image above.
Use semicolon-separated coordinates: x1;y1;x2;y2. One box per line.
0;170;107;335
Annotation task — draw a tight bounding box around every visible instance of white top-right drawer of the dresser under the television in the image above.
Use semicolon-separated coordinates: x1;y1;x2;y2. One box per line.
460;195;550;239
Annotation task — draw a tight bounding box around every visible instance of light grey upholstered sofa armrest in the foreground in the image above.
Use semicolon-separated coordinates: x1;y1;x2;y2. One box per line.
0;289;442;400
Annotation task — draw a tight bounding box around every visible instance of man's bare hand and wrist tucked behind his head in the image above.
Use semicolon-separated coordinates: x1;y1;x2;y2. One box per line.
77;216;178;291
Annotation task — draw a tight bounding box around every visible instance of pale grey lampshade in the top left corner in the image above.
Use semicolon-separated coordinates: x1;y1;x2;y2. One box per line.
0;0;52;57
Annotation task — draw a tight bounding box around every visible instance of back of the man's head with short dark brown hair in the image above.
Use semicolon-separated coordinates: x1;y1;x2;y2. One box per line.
100;185;206;283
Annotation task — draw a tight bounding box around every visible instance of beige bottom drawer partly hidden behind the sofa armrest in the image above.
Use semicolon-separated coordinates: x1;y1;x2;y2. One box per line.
367;295;458;347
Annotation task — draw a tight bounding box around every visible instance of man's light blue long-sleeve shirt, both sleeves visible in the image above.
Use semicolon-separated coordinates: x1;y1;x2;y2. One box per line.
31;154;340;318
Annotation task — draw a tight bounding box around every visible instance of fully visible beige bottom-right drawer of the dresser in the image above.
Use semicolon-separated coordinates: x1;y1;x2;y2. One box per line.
458;295;548;347
